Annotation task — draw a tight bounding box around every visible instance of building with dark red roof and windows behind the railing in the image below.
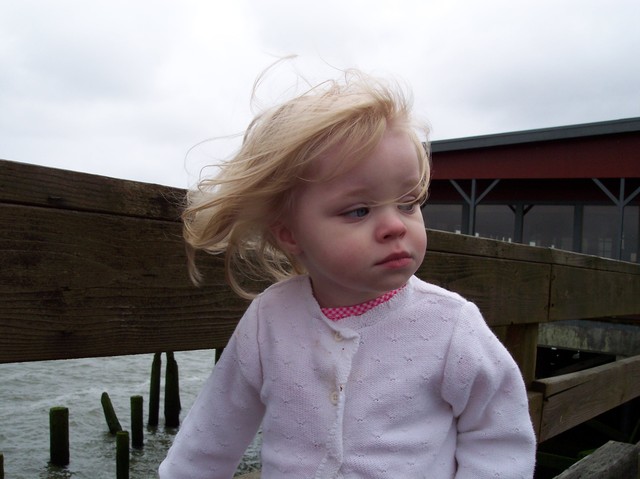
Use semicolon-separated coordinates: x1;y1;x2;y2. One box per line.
423;118;640;262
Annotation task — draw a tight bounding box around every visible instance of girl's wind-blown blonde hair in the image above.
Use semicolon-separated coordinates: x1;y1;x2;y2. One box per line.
182;70;430;298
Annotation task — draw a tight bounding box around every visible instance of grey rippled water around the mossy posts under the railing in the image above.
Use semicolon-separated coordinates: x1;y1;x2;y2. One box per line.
0;350;259;479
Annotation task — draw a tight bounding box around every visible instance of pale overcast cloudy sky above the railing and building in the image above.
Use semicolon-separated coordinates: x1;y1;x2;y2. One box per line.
0;0;640;187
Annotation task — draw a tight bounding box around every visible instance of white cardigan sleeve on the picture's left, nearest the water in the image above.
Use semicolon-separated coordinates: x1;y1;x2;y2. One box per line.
159;307;264;479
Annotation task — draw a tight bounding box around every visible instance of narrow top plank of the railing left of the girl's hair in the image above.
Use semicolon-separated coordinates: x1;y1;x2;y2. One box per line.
0;160;184;221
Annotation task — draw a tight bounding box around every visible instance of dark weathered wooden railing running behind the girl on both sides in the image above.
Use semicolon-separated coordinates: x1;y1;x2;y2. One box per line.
0;160;640;448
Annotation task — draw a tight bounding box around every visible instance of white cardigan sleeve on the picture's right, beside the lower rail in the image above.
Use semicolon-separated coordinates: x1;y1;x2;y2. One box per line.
443;302;536;479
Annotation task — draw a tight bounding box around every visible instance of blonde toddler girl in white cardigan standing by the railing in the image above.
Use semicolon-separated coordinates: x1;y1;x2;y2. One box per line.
160;72;535;479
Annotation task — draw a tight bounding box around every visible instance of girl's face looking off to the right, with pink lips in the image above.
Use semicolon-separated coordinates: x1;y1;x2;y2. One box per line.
274;129;427;307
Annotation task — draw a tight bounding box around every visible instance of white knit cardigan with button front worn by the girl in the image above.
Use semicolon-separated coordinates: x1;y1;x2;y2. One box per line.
160;276;536;479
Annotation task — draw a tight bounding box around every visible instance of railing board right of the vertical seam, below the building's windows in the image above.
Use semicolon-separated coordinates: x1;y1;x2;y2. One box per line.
549;264;640;321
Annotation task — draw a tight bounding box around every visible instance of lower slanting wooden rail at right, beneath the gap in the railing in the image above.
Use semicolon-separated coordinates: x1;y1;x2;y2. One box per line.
532;356;640;441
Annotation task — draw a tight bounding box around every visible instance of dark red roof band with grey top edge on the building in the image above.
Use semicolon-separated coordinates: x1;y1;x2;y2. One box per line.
431;118;640;180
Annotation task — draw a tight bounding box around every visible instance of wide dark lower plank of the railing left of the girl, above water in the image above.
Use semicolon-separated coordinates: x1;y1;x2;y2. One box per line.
0;205;246;362
